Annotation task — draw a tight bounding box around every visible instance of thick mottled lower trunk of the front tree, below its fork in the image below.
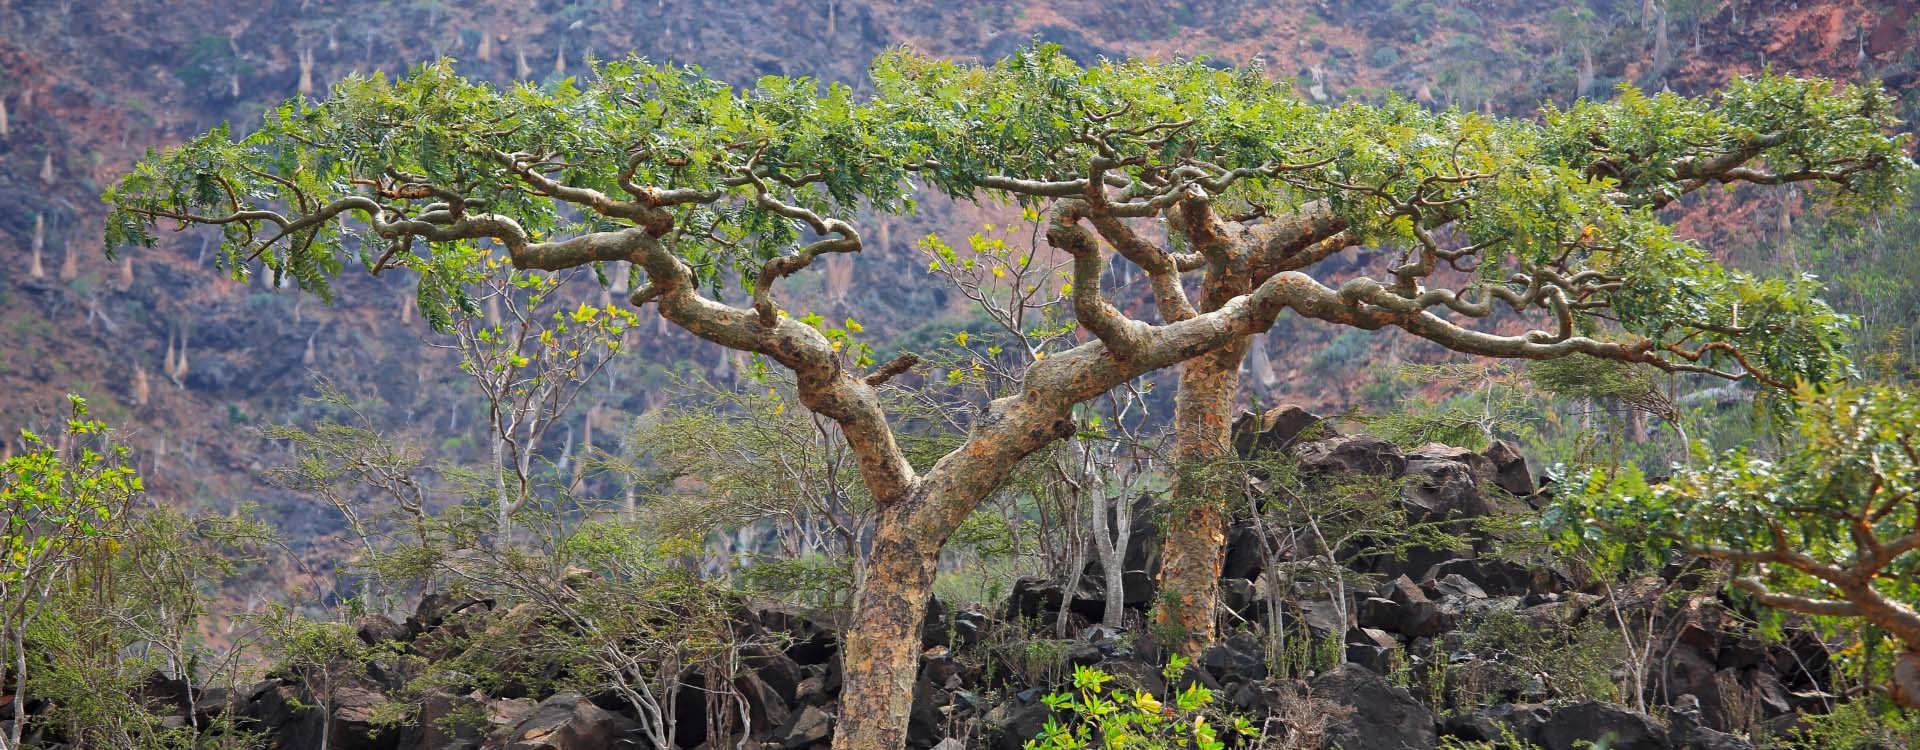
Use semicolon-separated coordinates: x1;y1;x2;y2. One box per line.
833;512;947;750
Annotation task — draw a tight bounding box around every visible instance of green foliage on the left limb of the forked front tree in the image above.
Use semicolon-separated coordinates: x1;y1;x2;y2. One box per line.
108;58;921;324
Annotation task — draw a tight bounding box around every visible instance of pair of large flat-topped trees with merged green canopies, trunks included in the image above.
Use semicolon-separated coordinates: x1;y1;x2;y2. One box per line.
108;46;1907;748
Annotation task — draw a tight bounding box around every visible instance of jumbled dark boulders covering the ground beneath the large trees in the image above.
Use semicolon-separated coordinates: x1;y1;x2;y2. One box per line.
15;416;1843;750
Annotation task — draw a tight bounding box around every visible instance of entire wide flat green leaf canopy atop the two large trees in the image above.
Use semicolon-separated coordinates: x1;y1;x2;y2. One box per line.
106;46;1910;382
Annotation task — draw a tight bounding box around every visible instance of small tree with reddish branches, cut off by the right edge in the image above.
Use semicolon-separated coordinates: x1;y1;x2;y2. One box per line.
1544;386;1920;708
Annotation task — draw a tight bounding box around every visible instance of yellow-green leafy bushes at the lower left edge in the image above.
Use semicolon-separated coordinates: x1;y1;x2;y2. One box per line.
0;404;271;750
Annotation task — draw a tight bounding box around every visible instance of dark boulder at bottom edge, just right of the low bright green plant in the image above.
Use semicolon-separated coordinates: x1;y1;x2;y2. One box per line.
1313;664;1440;750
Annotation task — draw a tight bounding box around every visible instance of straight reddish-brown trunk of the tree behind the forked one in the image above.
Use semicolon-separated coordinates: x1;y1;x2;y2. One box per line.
1154;338;1248;656
